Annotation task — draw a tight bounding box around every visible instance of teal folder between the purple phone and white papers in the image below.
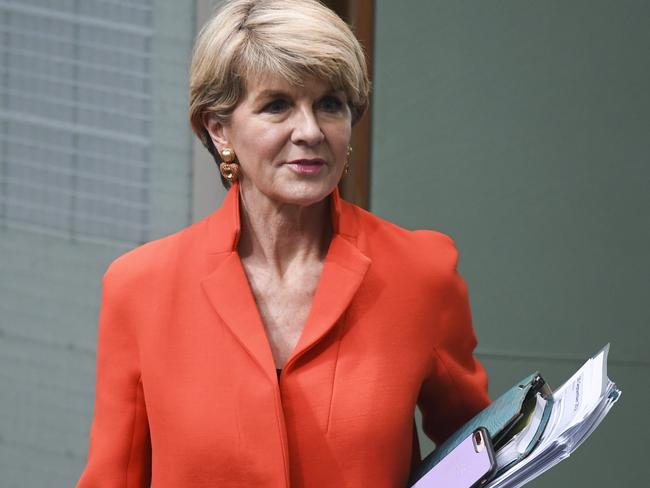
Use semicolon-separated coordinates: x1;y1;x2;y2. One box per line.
409;373;553;486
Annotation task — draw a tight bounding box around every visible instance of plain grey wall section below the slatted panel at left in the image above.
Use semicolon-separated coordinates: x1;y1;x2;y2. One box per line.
0;228;123;488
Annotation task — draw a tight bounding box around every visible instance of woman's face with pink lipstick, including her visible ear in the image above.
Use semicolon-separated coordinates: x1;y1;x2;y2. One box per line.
206;77;352;205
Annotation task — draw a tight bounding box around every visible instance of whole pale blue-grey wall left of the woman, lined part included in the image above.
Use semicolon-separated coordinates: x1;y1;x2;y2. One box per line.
0;0;194;488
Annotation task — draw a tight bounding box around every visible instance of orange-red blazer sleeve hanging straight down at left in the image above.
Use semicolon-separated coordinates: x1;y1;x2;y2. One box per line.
77;265;151;488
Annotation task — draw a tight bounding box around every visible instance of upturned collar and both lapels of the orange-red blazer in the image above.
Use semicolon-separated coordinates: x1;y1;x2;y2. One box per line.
202;183;371;383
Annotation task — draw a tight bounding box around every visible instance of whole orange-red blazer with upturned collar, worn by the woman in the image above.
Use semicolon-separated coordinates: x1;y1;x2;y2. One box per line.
77;185;489;488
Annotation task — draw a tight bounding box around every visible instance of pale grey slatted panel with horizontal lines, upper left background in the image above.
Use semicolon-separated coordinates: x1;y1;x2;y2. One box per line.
0;0;153;243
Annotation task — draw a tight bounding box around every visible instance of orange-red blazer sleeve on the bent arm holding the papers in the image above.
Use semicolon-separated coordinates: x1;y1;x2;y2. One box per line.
418;243;490;444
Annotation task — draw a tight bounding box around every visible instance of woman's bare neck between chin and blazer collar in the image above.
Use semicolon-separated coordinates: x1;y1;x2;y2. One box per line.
237;183;332;277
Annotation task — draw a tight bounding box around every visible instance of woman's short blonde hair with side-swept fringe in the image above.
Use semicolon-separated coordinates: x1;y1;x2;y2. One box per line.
189;0;370;151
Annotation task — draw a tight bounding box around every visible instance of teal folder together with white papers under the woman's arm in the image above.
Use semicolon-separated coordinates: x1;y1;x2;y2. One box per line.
409;344;621;488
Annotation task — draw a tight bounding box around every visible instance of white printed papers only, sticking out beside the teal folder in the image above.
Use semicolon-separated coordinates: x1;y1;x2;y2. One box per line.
486;344;621;488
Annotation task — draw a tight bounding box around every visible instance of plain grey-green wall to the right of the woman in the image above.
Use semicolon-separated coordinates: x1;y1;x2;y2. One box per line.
371;0;650;488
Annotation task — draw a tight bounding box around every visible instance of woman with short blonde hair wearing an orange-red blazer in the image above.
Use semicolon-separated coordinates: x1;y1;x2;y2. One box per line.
78;0;489;488
